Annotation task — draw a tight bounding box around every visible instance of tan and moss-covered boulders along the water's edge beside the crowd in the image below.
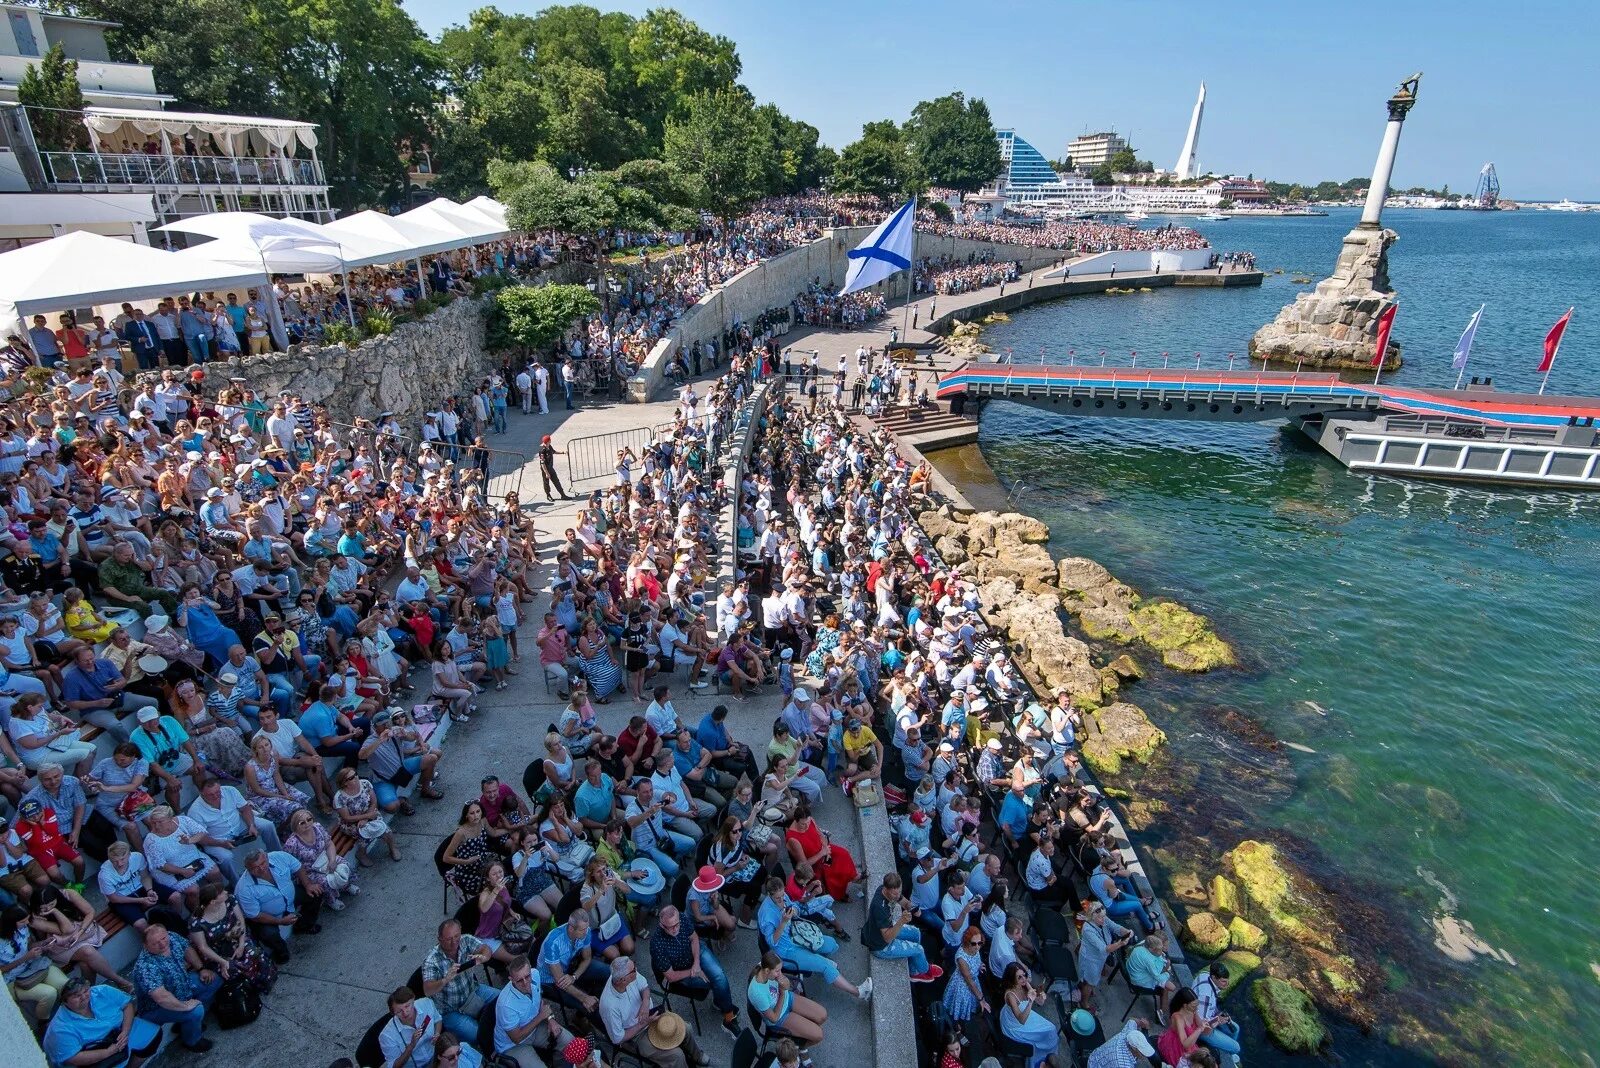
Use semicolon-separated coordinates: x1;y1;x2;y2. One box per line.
917;505;1414;1052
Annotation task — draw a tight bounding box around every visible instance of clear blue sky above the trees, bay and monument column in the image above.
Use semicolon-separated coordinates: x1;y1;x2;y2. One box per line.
405;0;1600;200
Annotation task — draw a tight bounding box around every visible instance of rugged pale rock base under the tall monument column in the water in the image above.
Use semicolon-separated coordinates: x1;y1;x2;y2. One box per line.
1250;227;1400;371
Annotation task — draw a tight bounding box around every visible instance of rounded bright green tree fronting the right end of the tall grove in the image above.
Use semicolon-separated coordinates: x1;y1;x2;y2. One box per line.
662;88;761;219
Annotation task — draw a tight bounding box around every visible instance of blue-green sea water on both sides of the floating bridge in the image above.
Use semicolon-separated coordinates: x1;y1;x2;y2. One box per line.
981;211;1600;1063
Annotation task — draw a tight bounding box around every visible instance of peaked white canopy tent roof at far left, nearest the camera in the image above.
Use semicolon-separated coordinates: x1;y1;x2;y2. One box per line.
0;232;267;323
